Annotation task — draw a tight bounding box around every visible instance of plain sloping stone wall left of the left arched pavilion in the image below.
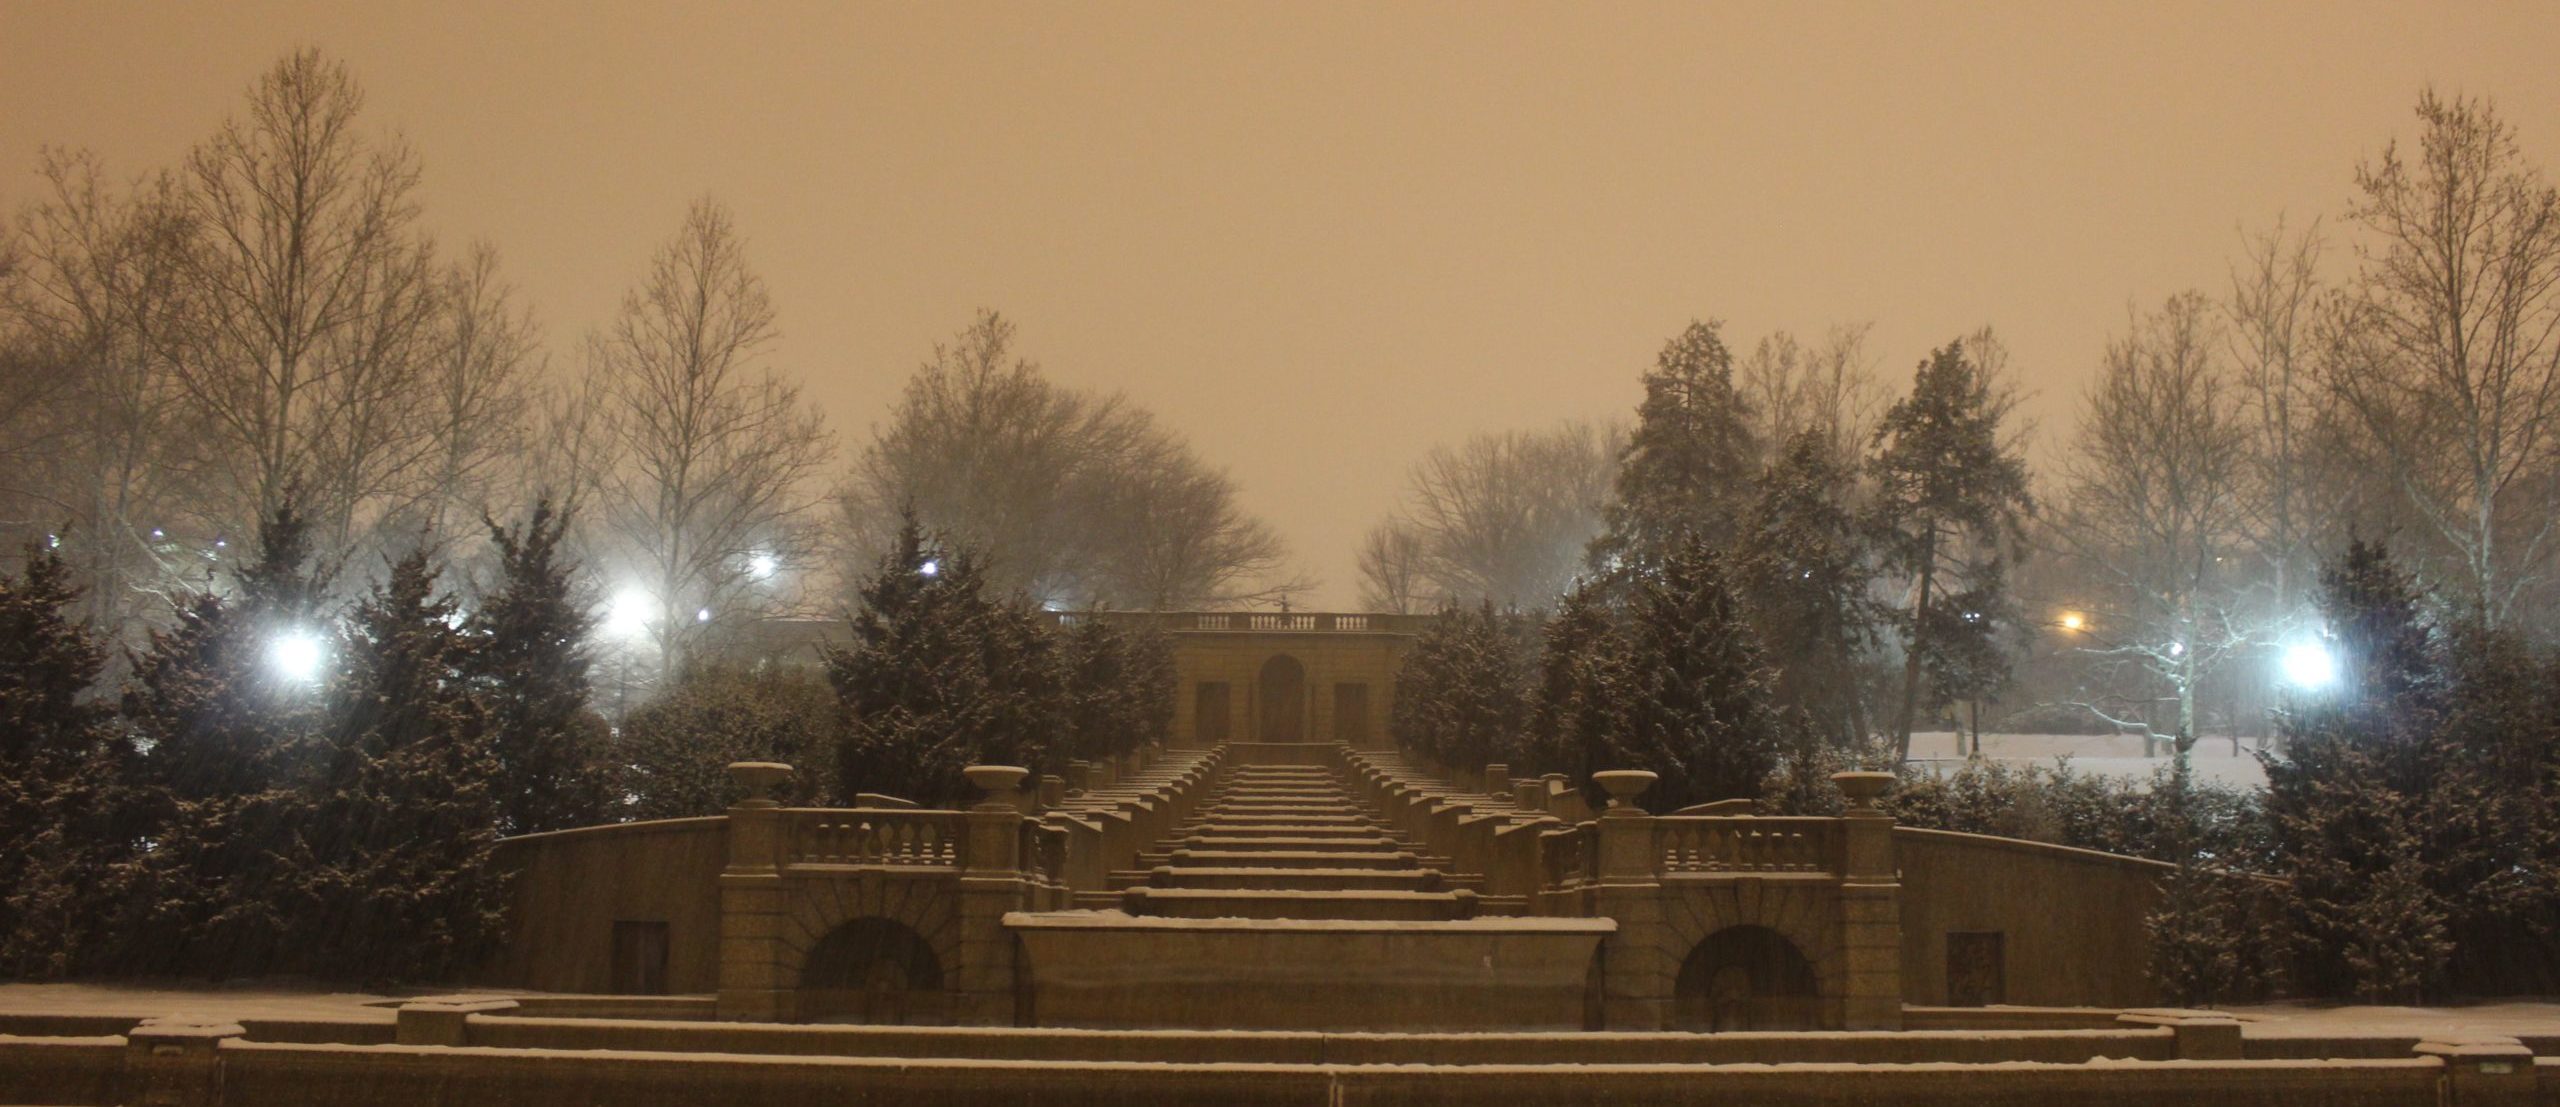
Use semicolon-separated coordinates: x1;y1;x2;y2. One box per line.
471;815;730;992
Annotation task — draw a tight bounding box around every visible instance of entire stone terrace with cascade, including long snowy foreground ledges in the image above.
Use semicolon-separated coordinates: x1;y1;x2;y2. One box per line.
0;615;2560;1104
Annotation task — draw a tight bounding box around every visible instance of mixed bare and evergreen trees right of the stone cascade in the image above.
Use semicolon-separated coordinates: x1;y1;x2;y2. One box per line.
1362;92;2560;1002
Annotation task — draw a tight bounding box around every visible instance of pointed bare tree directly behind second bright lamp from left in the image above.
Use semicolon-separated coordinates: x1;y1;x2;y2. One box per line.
589;200;835;674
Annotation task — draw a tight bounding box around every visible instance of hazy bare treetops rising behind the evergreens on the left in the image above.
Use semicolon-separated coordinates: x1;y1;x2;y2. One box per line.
0;51;1303;697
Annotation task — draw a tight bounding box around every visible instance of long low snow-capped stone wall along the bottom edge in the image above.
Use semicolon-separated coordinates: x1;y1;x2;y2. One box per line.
0;1038;2488;1107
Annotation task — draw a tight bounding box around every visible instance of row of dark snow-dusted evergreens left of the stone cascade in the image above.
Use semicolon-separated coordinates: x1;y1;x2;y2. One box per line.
0;497;1172;981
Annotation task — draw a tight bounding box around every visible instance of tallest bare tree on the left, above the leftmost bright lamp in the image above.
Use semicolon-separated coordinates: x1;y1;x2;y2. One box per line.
174;51;440;556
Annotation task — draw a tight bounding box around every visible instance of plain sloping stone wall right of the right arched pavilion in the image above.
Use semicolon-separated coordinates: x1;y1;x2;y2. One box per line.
1894;828;2171;1007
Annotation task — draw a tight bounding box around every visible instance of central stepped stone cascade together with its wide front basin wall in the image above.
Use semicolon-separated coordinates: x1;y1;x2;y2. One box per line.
1004;743;1618;1030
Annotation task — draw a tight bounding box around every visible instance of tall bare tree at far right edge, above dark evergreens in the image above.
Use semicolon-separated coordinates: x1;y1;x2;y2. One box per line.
2327;90;2560;625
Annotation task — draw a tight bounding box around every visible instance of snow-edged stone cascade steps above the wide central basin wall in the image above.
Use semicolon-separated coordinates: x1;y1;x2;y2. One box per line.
1111;766;1477;923
